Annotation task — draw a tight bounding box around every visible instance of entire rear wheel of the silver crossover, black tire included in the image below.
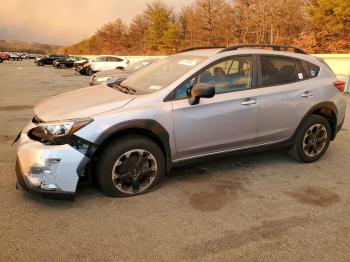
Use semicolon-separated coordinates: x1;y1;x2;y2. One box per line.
288;115;332;163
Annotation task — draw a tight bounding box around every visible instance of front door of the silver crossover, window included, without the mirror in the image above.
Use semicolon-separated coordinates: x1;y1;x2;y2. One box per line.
172;55;257;159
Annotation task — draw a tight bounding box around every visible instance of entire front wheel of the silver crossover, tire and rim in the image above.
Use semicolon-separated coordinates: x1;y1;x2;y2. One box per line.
96;135;165;197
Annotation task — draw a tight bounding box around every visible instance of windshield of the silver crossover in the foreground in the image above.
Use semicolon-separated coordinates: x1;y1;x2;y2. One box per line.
119;55;206;94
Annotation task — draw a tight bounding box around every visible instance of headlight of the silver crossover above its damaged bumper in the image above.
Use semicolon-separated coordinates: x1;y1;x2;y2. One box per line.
30;118;93;143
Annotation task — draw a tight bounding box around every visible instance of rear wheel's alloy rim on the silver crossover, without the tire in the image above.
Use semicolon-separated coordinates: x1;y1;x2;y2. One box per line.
303;124;328;157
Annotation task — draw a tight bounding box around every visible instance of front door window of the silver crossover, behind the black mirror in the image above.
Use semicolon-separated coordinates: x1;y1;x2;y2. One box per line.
175;56;252;99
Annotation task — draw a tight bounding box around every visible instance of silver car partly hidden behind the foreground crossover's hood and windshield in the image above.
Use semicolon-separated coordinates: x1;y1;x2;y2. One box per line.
90;59;159;86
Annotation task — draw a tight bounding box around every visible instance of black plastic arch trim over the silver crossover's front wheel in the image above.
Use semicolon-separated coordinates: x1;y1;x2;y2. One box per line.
94;119;172;172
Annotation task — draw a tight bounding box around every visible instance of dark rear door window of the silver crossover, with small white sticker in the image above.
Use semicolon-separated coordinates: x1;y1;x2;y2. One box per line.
260;56;307;87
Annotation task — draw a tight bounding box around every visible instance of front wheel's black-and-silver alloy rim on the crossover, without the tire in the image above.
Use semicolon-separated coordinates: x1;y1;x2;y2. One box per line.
112;149;157;195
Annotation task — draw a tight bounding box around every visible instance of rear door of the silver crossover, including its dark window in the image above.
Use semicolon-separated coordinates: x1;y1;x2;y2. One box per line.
256;55;317;144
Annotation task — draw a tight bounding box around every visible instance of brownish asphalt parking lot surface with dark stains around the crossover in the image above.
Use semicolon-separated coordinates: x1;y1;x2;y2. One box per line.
0;61;350;261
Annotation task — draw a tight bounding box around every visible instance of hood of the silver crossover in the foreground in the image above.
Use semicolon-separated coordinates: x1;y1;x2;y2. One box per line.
34;85;136;121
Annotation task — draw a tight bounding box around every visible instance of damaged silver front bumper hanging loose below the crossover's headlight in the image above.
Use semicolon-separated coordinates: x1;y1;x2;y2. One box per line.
16;123;88;200
